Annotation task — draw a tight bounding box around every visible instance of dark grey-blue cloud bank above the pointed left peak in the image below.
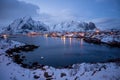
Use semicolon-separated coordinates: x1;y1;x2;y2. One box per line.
0;0;39;24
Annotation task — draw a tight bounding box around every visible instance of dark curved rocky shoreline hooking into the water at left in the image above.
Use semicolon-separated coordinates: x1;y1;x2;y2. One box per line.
5;44;40;69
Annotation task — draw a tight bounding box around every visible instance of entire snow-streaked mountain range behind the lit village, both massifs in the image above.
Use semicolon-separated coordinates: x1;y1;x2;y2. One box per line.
2;17;96;34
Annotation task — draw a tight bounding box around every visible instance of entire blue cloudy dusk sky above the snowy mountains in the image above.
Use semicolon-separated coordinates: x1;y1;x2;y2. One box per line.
0;0;120;26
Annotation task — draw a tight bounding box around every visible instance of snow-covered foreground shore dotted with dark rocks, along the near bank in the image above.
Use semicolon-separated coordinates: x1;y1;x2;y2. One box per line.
0;40;120;80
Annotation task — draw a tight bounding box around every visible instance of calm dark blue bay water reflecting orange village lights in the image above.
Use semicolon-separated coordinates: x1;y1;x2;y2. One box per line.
11;36;120;67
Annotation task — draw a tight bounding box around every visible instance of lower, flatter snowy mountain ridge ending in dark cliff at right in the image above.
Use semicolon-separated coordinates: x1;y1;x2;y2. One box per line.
51;21;96;31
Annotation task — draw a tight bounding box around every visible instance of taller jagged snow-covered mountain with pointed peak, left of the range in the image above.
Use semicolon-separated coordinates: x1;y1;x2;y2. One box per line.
3;17;49;34
